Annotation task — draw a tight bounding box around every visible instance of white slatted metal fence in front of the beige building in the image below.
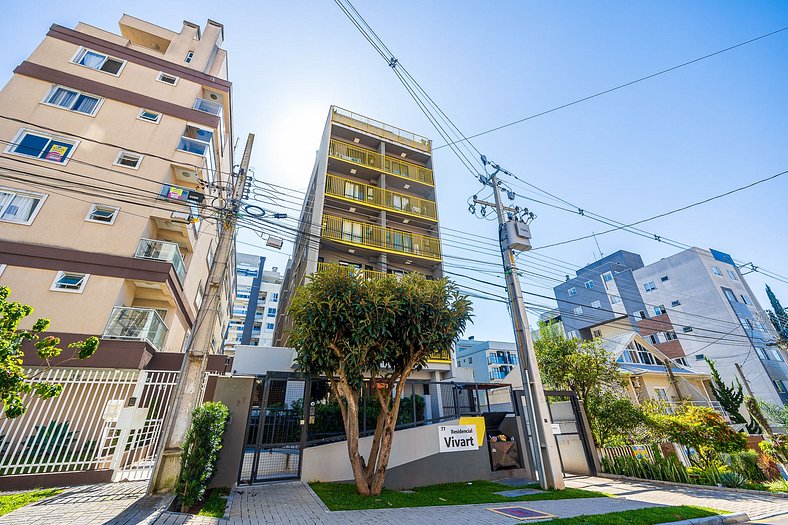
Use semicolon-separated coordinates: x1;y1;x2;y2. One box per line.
0;368;178;480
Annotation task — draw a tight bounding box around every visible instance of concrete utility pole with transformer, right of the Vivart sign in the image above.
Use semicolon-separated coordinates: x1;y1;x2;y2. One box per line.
474;157;564;489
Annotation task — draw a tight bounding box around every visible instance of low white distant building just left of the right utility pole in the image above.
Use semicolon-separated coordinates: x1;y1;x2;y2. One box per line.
457;338;518;383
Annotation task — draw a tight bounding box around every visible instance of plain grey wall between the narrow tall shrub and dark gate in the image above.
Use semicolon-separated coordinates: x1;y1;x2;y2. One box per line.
209;376;254;487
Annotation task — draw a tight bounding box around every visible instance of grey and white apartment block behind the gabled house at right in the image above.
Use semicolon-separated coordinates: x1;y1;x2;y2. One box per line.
554;248;788;403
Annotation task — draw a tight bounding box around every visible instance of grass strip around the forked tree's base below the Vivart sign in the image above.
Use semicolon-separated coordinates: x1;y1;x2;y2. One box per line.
309;481;608;508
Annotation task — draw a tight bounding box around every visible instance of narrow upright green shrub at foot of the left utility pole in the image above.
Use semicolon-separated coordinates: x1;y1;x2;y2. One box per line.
175;402;230;512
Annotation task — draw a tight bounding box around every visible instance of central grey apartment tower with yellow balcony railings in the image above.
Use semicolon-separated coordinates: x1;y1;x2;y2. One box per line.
274;106;451;370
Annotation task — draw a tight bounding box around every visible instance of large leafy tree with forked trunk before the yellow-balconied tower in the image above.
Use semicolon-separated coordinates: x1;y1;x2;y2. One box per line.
288;265;472;494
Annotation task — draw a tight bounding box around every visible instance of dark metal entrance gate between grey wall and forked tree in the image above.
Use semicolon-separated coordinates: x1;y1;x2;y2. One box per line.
238;378;306;483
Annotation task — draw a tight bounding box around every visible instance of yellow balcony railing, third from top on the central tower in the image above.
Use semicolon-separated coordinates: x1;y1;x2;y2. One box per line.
323;215;441;261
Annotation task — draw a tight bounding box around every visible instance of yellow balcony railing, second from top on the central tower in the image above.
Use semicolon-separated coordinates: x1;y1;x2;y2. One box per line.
326;175;438;221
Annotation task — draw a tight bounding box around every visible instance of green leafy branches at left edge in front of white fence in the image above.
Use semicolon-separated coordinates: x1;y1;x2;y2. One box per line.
0;286;99;419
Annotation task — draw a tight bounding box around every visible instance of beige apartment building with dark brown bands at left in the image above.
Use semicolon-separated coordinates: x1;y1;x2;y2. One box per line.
0;15;233;490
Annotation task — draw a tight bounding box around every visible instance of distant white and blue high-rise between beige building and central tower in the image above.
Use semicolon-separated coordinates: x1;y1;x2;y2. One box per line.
224;253;282;355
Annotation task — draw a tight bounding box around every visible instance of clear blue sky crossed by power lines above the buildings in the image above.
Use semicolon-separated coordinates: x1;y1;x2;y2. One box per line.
0;0;788;340
